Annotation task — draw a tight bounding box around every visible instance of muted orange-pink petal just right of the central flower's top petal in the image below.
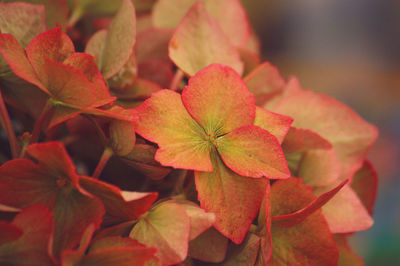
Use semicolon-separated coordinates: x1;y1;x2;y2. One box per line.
243;62;285;106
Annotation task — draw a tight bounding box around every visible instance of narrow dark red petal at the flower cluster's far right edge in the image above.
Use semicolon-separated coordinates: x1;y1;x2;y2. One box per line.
351;161;378;215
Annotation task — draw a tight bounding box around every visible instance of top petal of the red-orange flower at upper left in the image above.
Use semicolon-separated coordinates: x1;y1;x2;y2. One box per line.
26;27;75;78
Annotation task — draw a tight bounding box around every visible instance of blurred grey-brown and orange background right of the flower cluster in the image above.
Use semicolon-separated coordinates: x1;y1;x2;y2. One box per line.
243;0;400;265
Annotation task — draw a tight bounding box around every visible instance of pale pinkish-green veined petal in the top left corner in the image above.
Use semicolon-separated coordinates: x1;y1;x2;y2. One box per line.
0;2;46;47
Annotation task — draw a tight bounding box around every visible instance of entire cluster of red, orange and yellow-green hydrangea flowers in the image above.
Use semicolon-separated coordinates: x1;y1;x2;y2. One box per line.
0;0;378;265
